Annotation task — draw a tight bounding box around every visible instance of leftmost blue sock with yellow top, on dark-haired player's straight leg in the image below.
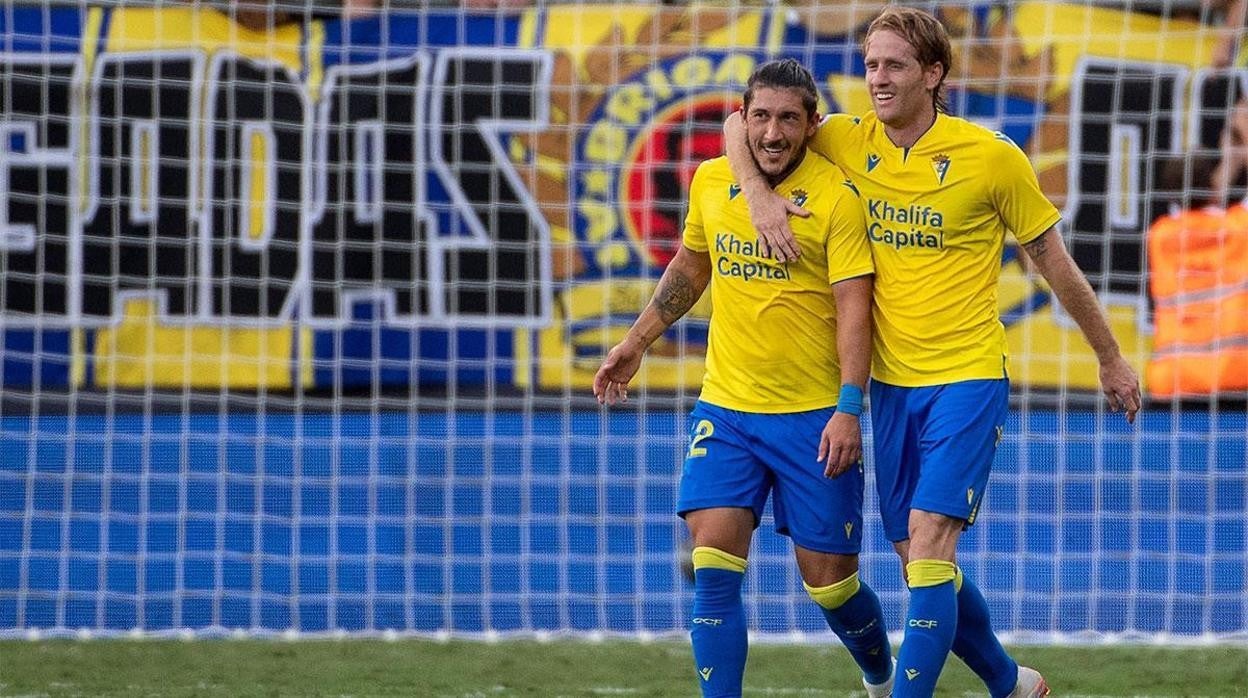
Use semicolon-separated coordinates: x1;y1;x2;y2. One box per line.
689;547;749;698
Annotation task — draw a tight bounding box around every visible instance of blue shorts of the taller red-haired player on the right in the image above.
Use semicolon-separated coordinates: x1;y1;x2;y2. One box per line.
871;378;1010;542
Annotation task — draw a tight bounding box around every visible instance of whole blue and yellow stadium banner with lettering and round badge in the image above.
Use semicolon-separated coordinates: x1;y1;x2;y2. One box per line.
0;2;1242;391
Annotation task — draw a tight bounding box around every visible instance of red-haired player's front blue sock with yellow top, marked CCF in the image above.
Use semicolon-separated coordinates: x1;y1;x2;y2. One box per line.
892;559;957;698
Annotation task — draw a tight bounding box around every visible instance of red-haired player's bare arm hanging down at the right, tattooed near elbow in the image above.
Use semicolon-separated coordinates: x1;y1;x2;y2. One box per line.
1022;227;1142;423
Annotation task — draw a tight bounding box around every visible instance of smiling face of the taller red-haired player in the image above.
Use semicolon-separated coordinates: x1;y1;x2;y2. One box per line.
866;30;945;137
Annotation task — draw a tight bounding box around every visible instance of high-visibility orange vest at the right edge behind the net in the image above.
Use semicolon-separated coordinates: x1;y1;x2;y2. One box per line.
1144;202;1248;397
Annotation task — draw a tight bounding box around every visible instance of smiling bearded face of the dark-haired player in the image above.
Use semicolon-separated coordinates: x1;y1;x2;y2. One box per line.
745;87;819;185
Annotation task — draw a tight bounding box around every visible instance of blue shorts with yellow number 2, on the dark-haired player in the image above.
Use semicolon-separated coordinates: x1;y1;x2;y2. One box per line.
676;401;862;554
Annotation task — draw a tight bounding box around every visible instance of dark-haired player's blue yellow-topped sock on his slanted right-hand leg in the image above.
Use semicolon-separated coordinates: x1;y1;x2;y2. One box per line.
802;572;892;683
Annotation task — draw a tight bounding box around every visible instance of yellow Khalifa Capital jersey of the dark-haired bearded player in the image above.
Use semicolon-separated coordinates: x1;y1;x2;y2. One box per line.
684;150;875;413
